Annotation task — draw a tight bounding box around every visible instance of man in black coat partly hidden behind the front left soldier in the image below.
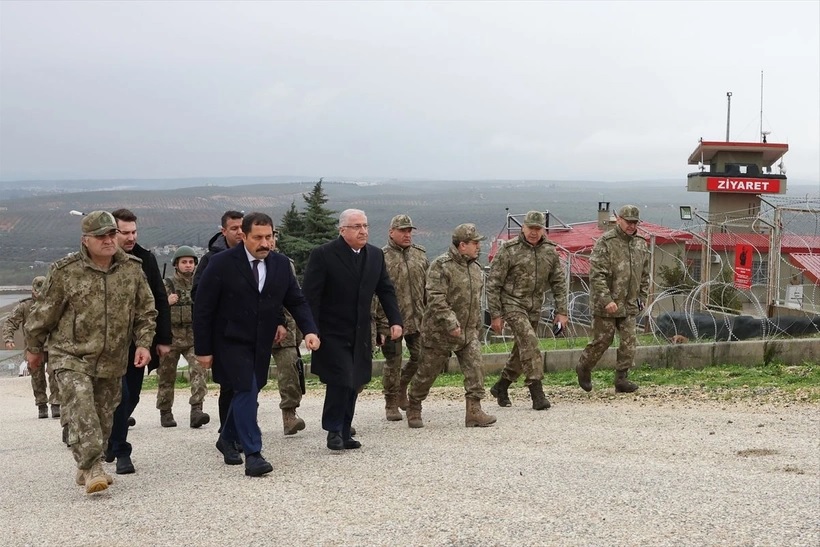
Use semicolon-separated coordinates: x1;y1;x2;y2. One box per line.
105;209;171;475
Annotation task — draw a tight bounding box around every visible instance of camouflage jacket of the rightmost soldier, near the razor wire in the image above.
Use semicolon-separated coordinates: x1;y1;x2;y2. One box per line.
589;226;649;317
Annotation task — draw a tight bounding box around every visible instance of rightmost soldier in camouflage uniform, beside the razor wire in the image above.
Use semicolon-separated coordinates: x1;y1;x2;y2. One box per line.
575;205;649;393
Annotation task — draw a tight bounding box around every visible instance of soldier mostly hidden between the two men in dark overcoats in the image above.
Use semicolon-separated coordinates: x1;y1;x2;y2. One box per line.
270;255;305;435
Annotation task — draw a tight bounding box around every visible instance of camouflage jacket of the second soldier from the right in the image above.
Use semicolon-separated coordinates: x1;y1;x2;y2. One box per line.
487;234;567;319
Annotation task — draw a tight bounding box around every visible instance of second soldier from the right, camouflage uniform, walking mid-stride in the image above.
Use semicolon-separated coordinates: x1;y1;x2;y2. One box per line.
487;211;567;410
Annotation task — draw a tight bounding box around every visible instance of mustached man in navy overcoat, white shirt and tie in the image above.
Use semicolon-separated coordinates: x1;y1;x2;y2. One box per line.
194;213;319;477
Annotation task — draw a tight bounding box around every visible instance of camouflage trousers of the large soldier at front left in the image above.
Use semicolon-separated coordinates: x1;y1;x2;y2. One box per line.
56;369;122;469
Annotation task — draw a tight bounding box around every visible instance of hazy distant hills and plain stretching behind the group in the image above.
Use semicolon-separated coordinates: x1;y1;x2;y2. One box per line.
0;177;817;285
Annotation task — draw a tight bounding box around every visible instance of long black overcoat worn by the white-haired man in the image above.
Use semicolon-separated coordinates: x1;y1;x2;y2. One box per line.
302;236;402;388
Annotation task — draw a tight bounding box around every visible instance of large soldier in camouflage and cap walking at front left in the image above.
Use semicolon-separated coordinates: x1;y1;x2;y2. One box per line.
26;211;157;494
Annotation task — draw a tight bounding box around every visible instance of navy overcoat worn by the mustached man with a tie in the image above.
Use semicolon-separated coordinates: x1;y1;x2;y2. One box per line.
194;245;318;391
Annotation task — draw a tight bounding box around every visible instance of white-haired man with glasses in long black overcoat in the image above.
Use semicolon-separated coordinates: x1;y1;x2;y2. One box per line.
303;209;402;450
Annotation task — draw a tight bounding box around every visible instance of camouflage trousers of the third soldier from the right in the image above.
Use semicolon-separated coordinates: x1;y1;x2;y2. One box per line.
407;337;484;401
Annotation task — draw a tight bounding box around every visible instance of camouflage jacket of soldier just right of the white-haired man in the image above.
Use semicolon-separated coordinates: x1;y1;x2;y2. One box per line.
373;239;430;335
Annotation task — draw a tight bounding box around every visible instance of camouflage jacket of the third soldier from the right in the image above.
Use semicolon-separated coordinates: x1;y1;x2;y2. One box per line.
421;245;484;351
